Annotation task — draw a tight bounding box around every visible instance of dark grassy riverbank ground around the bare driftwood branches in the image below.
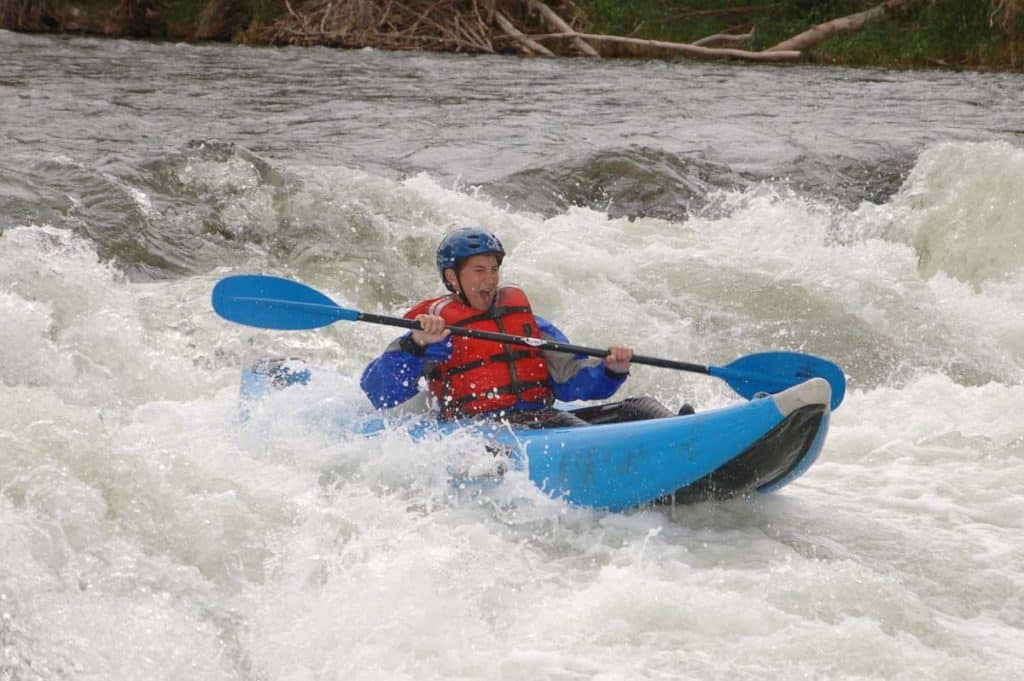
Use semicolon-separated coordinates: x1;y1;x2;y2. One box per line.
0;0;1024;71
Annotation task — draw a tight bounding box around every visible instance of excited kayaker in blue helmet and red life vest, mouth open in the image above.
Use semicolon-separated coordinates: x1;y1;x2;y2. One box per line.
359;227;692;427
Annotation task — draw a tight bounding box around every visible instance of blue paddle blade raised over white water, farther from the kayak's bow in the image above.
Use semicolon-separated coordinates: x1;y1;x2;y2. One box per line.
213;274;359;330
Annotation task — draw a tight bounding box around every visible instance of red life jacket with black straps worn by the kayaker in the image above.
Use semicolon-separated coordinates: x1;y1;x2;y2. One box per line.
406;286;554;419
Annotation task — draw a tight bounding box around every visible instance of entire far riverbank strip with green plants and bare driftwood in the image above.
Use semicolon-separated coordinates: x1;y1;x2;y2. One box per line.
0;0;1024;70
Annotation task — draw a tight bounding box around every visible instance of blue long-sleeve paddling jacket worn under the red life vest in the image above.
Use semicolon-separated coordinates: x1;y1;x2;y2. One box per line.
359;314;627;411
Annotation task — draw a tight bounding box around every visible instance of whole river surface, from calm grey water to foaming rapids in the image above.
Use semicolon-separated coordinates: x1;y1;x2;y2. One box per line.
0;32;1024;681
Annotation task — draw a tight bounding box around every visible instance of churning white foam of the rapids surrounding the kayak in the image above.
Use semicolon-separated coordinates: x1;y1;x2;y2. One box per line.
0;139;1024;681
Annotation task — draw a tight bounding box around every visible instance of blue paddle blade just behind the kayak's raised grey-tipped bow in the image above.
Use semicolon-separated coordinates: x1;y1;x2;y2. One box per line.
708;352;846;410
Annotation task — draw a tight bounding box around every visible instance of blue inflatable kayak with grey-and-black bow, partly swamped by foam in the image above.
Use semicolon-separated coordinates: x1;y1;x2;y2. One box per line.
242;359;831;511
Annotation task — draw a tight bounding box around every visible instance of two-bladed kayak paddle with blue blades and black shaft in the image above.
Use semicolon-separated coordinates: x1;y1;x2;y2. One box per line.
213;274;846;410
